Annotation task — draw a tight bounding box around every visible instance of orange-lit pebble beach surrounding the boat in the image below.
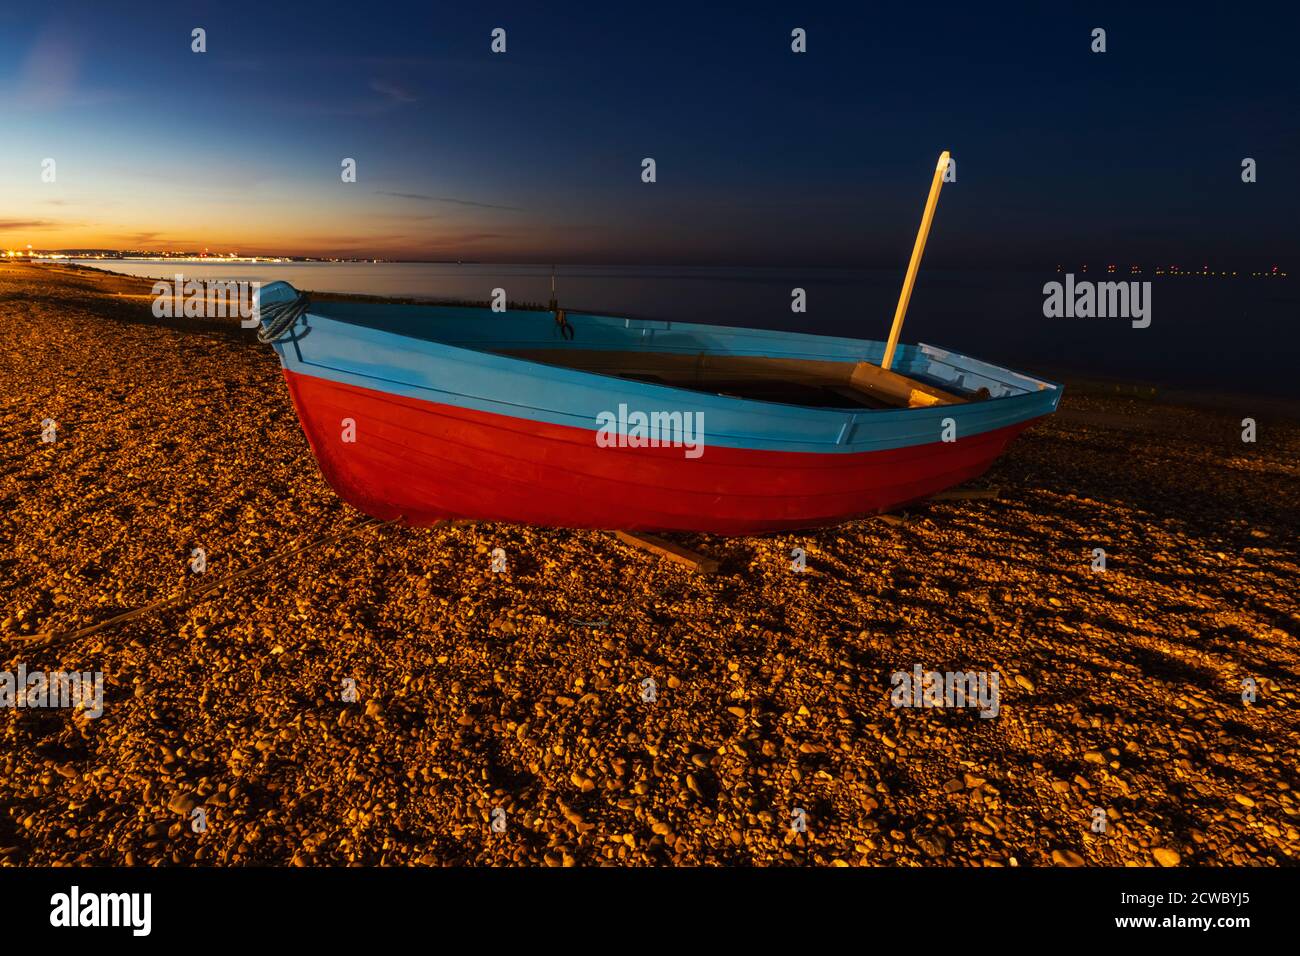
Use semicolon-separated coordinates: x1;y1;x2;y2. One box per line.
0;263;1300;866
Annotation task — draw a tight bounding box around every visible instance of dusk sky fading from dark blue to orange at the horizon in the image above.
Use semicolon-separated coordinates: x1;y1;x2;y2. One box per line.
0;3;1300;268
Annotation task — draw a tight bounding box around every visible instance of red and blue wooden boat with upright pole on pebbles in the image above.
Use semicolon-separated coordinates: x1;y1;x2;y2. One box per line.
253;153;1061;535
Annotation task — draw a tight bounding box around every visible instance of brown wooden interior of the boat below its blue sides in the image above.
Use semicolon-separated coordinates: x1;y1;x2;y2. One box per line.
499;349;989;408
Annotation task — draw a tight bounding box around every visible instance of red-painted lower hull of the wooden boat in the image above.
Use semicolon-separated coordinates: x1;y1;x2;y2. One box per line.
285;369;1032;535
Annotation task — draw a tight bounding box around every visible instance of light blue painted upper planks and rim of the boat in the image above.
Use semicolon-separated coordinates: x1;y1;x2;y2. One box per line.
261;282;1061;454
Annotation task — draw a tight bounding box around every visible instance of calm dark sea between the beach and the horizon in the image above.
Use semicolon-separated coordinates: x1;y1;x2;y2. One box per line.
76;260;1300;397
